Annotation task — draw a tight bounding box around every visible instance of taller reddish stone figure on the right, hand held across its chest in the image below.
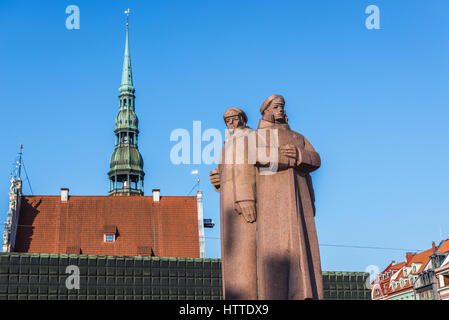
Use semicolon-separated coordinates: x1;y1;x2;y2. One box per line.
254;95;323;300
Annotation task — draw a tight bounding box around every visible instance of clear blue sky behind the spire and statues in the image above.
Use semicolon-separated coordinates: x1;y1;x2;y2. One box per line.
0;0;449;271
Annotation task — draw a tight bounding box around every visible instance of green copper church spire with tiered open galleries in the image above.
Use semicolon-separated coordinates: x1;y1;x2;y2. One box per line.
108;18;145;196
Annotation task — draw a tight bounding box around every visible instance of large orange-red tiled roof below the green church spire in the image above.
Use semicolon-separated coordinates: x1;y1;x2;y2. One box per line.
14;196;200;258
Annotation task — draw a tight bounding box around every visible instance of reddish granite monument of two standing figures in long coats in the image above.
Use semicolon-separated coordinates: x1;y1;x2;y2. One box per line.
210;95;323;300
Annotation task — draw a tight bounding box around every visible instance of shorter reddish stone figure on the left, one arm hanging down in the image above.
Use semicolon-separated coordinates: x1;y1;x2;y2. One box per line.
210;108;258;300
